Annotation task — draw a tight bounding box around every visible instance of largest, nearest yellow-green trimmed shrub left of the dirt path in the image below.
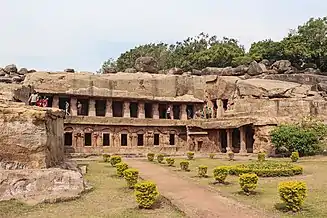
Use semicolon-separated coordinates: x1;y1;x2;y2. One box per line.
135;181;159;209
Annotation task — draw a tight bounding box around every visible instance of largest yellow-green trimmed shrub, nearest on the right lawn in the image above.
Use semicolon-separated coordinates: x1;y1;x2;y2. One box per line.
278;181;307;212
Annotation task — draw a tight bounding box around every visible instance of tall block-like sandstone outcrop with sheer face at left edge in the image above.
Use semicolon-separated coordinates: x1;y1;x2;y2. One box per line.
0;102;64;169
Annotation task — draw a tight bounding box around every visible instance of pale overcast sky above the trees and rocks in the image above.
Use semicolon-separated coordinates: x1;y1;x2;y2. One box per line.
0;0;327;71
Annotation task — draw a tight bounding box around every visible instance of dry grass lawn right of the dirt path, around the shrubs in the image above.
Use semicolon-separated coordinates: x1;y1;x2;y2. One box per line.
155;156;327;218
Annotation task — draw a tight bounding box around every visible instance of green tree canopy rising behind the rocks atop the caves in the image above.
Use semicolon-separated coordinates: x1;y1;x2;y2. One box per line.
101;17;327;71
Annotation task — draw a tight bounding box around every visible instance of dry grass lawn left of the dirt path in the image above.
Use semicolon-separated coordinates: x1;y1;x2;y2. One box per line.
0;161;183;218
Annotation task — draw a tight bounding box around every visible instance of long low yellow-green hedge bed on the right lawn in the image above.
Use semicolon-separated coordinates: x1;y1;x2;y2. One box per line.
229;161;303;177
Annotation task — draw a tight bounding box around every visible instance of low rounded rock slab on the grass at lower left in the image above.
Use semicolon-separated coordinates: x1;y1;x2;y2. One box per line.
0;168;87;205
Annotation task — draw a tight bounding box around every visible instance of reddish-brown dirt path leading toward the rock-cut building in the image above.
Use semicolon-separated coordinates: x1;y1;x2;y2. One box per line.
125;159;268;218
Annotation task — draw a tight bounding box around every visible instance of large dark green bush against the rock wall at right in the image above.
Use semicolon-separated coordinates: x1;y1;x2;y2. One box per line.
270;118;327;156
